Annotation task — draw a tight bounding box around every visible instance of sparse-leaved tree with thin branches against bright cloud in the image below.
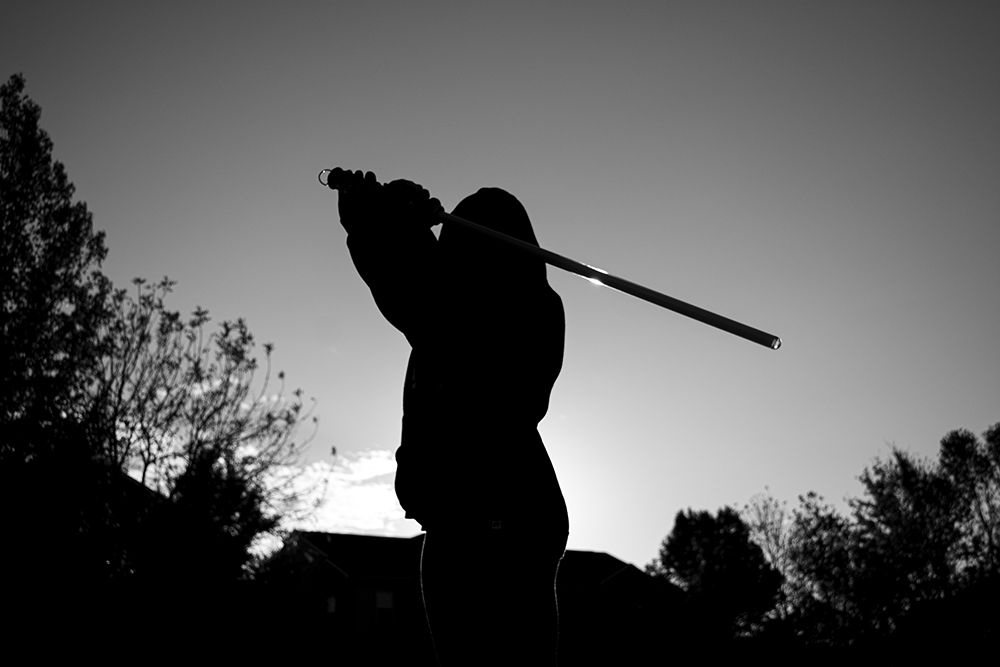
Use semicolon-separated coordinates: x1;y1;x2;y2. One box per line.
91;278;320;576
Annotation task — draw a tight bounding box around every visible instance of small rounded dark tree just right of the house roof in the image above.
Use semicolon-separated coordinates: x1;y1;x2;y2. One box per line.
646;507;781;638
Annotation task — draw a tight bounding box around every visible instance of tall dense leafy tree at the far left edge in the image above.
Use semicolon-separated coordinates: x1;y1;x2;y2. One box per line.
0;75;110;465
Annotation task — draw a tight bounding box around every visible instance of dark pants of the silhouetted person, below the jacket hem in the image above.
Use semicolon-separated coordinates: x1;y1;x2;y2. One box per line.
420;528;567;667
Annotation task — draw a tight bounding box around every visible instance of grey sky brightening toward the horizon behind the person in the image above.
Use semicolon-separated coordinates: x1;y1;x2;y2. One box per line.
0;0;1000;567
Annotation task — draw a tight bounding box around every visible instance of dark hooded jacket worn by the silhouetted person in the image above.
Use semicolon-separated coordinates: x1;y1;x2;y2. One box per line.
348;188;568;531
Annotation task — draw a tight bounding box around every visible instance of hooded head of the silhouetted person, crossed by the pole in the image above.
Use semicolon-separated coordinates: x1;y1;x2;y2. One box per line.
440;188;547;287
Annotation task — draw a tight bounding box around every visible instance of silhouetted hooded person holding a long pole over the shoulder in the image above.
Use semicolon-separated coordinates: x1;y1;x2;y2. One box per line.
331;172;569;665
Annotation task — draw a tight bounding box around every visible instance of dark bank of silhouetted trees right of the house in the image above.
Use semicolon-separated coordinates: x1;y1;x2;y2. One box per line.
646;423;1000;654
